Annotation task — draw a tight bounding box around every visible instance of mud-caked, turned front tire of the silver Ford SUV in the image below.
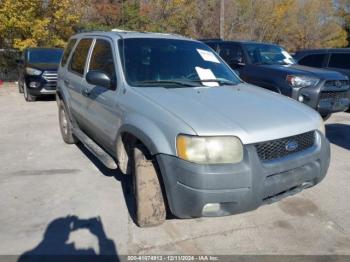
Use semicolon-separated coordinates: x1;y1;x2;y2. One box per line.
132;145;166;227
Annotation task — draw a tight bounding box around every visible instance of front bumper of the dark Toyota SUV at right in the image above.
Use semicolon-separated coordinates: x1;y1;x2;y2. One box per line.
292;81;350;116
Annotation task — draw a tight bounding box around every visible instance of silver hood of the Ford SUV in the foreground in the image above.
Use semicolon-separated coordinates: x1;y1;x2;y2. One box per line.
136;83;321;144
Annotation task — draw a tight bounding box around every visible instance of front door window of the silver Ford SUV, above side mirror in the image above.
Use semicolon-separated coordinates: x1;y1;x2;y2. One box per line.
89;39;116;80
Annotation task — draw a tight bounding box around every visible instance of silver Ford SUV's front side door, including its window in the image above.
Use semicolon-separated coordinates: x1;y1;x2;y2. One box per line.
84;37;120;152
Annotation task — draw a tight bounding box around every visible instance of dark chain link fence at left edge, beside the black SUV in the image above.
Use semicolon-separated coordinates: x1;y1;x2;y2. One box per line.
0;49;21;81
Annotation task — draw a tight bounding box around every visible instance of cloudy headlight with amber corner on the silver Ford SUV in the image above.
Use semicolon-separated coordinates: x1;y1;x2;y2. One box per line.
176;135;243;164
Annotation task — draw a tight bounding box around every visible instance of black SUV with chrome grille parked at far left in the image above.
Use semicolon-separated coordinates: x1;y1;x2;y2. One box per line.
18;48;63;101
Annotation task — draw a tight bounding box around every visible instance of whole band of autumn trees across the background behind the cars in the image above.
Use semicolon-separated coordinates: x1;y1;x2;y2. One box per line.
0;0;350;50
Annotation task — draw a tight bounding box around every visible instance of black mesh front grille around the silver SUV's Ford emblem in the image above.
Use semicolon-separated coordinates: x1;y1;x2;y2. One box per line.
255;131;315;161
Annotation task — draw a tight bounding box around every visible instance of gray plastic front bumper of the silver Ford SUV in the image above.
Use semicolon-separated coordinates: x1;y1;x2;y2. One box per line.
157;133;330;218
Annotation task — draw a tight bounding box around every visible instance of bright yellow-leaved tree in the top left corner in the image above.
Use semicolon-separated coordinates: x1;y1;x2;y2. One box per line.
0;0;80;50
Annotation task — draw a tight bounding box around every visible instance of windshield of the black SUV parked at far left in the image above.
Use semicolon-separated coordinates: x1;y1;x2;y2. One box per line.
27;49;63;64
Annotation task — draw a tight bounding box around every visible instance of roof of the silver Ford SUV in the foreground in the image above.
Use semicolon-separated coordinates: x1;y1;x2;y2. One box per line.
73;29;194;41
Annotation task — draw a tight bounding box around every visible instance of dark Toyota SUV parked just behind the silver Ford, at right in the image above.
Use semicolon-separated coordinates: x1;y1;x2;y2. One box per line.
202;39;350;119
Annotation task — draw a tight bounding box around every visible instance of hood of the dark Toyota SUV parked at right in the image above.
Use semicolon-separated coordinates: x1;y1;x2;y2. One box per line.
259;64;346;80
